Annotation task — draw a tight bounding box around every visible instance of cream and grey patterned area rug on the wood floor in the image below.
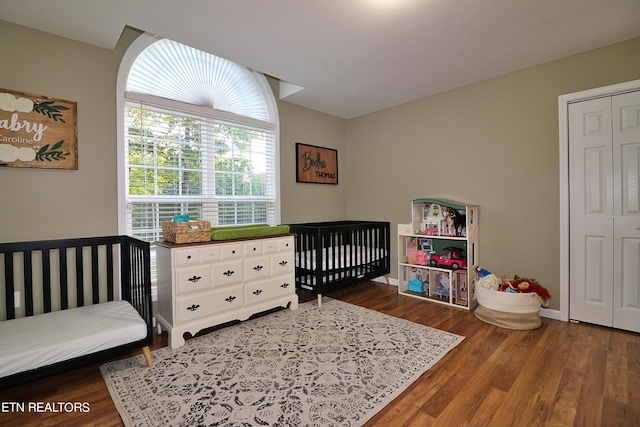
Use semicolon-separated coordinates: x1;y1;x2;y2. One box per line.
100;297;464;427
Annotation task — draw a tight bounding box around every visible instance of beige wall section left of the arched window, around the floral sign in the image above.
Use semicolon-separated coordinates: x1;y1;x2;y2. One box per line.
0;21;121;242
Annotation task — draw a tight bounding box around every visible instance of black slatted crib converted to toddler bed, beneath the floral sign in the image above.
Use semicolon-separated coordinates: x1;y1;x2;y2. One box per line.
0;236;153;388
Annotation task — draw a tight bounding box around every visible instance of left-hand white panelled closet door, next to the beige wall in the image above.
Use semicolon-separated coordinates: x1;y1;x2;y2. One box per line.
569;98;614;326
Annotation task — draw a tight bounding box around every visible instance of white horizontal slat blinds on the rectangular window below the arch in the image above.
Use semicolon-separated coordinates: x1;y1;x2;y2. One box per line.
125;100;276;241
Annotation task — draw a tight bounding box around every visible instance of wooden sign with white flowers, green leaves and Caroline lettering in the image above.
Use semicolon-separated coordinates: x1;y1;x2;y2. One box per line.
0;88;78;170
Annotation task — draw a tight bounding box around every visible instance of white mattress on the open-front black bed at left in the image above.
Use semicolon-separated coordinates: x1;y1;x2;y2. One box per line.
0;301;147;377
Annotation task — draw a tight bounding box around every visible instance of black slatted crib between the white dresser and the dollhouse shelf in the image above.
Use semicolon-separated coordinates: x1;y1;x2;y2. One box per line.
289;221;391;304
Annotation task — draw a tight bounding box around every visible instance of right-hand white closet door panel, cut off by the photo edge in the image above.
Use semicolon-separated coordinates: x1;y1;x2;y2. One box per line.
612;92;640;332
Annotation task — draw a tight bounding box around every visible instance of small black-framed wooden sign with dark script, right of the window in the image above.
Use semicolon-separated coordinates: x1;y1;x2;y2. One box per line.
296;142;338;184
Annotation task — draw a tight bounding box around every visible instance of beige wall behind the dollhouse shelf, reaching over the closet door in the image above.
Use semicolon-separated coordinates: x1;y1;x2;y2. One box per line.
347;39;640;309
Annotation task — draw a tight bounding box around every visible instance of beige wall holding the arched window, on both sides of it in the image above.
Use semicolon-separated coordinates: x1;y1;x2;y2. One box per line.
0;20;347;242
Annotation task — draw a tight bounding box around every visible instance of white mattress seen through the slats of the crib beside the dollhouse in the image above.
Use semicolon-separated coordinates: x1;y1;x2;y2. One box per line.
296;245;387;271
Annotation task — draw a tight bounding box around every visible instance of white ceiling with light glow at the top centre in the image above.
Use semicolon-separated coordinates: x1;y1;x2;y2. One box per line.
0;0;640;118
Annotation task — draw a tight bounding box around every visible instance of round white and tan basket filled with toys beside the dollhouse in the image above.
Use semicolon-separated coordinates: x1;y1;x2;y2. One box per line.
475;267;550;330
